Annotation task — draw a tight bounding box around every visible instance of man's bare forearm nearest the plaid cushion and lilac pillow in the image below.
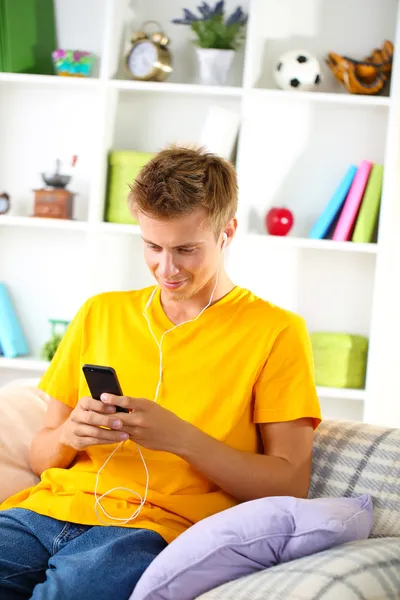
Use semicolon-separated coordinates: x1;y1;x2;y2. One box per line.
177;427;308;500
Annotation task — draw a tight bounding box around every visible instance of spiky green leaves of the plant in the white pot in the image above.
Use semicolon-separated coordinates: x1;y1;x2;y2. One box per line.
172;0;247;50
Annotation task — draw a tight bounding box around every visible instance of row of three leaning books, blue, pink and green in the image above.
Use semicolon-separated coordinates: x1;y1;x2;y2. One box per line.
309;160;383;243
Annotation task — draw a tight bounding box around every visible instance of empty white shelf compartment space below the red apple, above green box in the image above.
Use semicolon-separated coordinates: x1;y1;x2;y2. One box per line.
227;235;376;337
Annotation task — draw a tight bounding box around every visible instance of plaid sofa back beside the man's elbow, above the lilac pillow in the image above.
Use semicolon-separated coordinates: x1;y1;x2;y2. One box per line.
309;421;400;536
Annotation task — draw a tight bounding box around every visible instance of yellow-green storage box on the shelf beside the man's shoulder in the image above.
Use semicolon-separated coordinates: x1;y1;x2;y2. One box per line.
311;332;368;389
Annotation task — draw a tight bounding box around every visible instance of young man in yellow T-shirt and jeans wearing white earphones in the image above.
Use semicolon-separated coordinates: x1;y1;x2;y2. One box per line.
0;148;320;600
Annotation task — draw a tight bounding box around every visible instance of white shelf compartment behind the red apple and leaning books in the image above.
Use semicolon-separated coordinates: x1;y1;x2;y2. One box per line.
239;97;390;240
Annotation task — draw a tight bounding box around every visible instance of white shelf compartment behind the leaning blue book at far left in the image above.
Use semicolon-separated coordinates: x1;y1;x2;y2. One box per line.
0;227;91;358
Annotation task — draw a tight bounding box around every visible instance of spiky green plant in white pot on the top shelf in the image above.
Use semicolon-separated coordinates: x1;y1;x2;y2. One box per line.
172;0;247;85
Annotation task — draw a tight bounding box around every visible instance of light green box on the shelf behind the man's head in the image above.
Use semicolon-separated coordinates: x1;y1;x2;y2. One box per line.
104;150;154;225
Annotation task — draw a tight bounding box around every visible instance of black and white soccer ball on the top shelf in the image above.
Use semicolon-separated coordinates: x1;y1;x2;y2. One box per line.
273;50;322;92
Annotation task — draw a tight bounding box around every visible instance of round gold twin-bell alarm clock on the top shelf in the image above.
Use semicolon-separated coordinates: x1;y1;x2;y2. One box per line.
126;21;172;81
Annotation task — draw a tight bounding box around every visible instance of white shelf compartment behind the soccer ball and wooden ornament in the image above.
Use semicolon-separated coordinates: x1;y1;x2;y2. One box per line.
248;0;398;95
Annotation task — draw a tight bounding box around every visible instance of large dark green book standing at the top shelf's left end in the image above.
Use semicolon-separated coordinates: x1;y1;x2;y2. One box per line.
0;0;57;74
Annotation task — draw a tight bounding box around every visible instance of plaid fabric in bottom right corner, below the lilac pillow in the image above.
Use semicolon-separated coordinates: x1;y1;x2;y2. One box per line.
198;538;400;600
